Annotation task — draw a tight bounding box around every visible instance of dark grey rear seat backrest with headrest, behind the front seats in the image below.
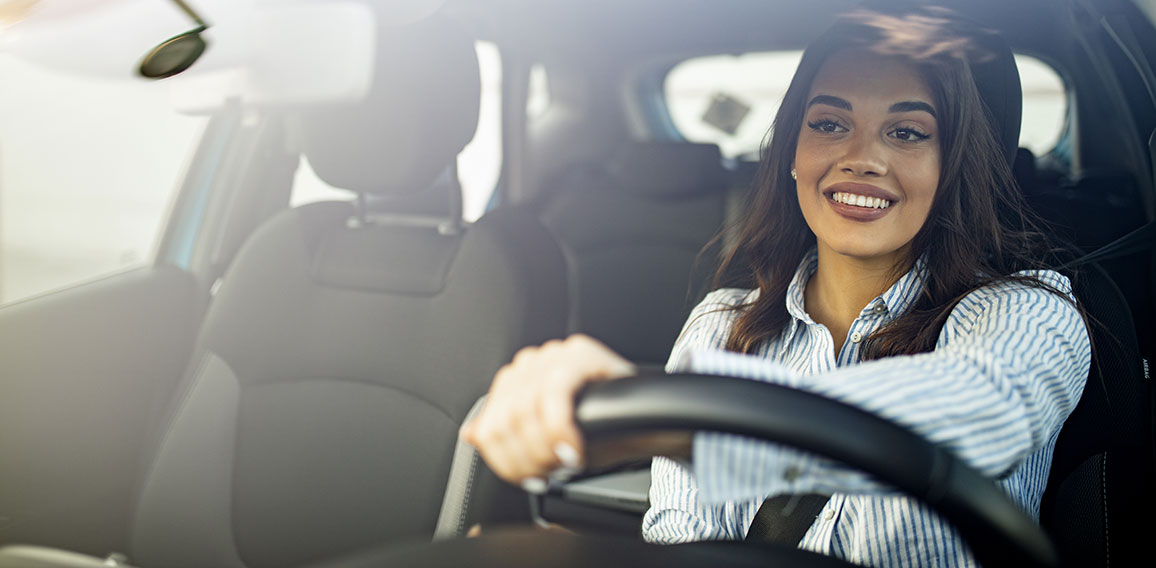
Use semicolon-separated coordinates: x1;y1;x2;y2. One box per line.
538;142;727;363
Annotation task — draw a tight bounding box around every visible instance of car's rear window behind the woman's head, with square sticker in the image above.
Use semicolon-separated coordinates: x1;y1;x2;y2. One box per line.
664;51;1067;160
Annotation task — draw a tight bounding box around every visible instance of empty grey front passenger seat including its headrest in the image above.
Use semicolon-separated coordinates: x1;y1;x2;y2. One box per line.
131;13;568;568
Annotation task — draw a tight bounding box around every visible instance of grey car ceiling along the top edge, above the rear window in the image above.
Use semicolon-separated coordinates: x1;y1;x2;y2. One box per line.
450;0;1068;59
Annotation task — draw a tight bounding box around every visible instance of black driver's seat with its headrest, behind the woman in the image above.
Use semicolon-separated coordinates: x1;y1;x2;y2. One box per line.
952;30;1153;566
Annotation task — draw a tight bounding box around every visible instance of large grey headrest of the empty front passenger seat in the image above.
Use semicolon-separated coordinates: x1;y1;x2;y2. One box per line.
302;15;481;193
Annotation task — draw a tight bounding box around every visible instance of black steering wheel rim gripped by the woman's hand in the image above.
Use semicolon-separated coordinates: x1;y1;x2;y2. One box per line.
575;372;1059;567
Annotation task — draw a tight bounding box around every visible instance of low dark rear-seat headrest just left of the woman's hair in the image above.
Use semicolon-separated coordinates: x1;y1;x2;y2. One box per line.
608;142;725;197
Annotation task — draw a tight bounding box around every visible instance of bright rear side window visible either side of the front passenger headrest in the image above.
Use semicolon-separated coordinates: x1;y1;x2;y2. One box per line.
290;42;502;221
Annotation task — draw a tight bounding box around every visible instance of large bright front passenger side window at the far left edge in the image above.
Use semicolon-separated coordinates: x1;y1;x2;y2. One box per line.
0;54;207;303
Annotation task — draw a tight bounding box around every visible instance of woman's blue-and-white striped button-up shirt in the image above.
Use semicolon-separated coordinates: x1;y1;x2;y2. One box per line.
643;252;1091;567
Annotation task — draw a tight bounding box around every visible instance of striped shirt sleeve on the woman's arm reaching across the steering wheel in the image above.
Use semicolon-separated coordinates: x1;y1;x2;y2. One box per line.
681;272;1091;504
